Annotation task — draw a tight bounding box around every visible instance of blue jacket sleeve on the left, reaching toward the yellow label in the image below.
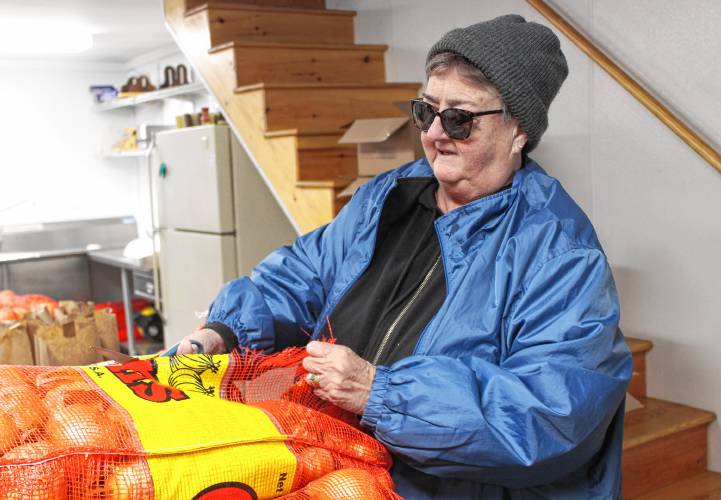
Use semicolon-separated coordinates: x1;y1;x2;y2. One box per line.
206;186;365;352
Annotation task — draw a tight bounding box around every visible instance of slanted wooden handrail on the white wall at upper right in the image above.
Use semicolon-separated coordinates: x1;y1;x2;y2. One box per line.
526;0;721;176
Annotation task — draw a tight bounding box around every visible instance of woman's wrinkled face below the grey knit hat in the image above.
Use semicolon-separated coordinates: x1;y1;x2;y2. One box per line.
421;69;526;204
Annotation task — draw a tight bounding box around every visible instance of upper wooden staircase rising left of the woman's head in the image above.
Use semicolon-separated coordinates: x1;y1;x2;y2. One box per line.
165;0;420;232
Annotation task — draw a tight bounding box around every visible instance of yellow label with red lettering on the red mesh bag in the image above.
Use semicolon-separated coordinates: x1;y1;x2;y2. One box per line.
84;354;297;499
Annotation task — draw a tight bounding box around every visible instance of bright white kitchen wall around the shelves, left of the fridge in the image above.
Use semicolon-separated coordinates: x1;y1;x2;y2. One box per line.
0;48;211;239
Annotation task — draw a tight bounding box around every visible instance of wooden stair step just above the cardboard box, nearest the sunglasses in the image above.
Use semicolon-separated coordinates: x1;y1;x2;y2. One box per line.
236;83;420;132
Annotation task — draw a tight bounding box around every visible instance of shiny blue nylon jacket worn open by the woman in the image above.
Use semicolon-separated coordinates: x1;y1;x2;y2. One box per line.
208;159;632;499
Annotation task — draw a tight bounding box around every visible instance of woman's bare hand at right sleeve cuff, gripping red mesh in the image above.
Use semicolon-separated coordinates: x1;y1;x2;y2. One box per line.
303;341;376;415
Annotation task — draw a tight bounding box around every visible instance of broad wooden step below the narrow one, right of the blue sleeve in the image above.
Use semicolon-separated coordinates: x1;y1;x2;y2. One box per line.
623;398;716;498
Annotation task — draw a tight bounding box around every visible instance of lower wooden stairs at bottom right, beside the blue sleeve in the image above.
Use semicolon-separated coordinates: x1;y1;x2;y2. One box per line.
623;338;721;500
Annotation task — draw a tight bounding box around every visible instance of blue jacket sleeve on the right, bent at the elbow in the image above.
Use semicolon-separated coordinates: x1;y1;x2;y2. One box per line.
362;249;631;488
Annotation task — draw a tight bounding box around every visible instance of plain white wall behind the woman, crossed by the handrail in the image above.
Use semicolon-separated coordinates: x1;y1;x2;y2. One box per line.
327;0;721;471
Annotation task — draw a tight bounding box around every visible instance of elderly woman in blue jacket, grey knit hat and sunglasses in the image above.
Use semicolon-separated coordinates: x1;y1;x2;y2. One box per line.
180;15;631;499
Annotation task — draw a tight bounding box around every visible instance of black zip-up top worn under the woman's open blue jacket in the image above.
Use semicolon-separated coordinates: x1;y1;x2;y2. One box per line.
323;178;446;365
